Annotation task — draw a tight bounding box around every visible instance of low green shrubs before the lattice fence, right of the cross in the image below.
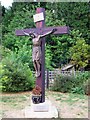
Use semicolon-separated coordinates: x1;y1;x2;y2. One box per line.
52;71;90;94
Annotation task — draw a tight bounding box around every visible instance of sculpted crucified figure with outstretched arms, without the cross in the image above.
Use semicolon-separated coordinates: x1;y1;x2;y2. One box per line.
23;29;57;77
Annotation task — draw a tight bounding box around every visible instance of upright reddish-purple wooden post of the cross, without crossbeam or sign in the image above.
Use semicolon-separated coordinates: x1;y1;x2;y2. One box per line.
36;8;45;103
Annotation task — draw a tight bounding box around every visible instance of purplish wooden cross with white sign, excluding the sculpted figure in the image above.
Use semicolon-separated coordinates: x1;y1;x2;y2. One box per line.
16;8;69;103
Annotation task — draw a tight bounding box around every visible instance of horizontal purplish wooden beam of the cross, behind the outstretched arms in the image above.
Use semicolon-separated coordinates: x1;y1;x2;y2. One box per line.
16;26;69;36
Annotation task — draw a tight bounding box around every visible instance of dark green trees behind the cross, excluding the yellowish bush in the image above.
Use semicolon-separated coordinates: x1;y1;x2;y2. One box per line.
2;2;89;67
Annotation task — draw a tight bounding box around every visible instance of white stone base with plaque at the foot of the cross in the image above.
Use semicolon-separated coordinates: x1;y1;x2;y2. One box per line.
25;100;58;118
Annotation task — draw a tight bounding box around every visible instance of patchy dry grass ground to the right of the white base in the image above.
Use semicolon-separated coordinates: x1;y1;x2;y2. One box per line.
48;92;88;118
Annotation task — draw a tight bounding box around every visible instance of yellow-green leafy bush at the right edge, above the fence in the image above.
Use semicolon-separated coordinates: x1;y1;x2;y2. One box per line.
70;38;90;68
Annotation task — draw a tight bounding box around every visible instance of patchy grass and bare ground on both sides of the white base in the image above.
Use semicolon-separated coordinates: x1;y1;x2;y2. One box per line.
0;91;90;118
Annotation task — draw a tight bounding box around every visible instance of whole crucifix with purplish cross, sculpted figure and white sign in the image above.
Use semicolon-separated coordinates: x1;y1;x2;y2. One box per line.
16;8;69;103
